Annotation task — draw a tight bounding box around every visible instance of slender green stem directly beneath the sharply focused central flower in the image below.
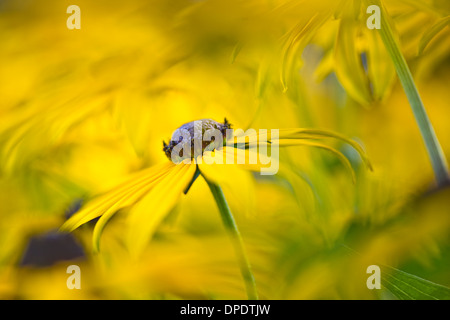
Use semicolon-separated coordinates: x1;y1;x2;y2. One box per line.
203;170;258;300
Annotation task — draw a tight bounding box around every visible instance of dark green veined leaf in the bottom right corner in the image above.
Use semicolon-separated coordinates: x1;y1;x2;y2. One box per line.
381;266;450;300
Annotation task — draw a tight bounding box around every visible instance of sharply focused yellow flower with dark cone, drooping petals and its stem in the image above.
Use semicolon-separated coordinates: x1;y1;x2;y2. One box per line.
61;119;370;300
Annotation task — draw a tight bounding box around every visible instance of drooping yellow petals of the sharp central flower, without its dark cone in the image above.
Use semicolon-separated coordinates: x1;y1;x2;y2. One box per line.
61;119;370;251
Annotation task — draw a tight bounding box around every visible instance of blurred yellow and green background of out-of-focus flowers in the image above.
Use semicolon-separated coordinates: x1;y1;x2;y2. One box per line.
0;0;450;299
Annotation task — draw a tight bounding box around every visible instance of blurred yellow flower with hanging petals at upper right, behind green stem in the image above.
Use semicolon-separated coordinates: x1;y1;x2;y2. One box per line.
281;0;450;106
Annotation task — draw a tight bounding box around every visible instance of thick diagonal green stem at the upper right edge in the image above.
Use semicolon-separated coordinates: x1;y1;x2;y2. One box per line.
367;0;449;186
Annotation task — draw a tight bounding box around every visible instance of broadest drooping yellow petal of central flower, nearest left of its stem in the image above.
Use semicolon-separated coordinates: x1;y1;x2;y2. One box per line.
127;163;197;256
